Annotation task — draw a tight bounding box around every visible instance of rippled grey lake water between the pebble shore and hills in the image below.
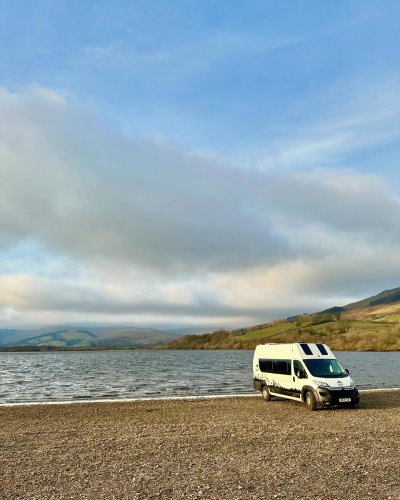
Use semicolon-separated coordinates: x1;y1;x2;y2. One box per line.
0;350;400;404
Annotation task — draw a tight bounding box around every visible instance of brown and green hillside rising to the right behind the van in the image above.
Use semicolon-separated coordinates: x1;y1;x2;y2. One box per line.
162;288;400;351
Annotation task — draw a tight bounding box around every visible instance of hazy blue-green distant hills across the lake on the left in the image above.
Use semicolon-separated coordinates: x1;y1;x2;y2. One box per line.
0;326;178;349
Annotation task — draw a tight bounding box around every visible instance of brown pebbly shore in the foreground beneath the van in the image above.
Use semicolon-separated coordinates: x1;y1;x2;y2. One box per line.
0;391;400;500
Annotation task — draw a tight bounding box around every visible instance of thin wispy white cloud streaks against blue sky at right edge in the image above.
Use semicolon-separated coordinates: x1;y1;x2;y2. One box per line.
258;72;400;169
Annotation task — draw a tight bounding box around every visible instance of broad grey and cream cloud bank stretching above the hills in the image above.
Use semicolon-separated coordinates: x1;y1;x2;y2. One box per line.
0;87;400;326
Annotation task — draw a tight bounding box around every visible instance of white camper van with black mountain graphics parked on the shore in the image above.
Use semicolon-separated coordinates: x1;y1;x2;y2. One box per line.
253;342;359;410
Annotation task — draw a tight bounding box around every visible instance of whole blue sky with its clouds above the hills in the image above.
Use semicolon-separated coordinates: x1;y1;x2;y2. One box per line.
0;0;400;329
